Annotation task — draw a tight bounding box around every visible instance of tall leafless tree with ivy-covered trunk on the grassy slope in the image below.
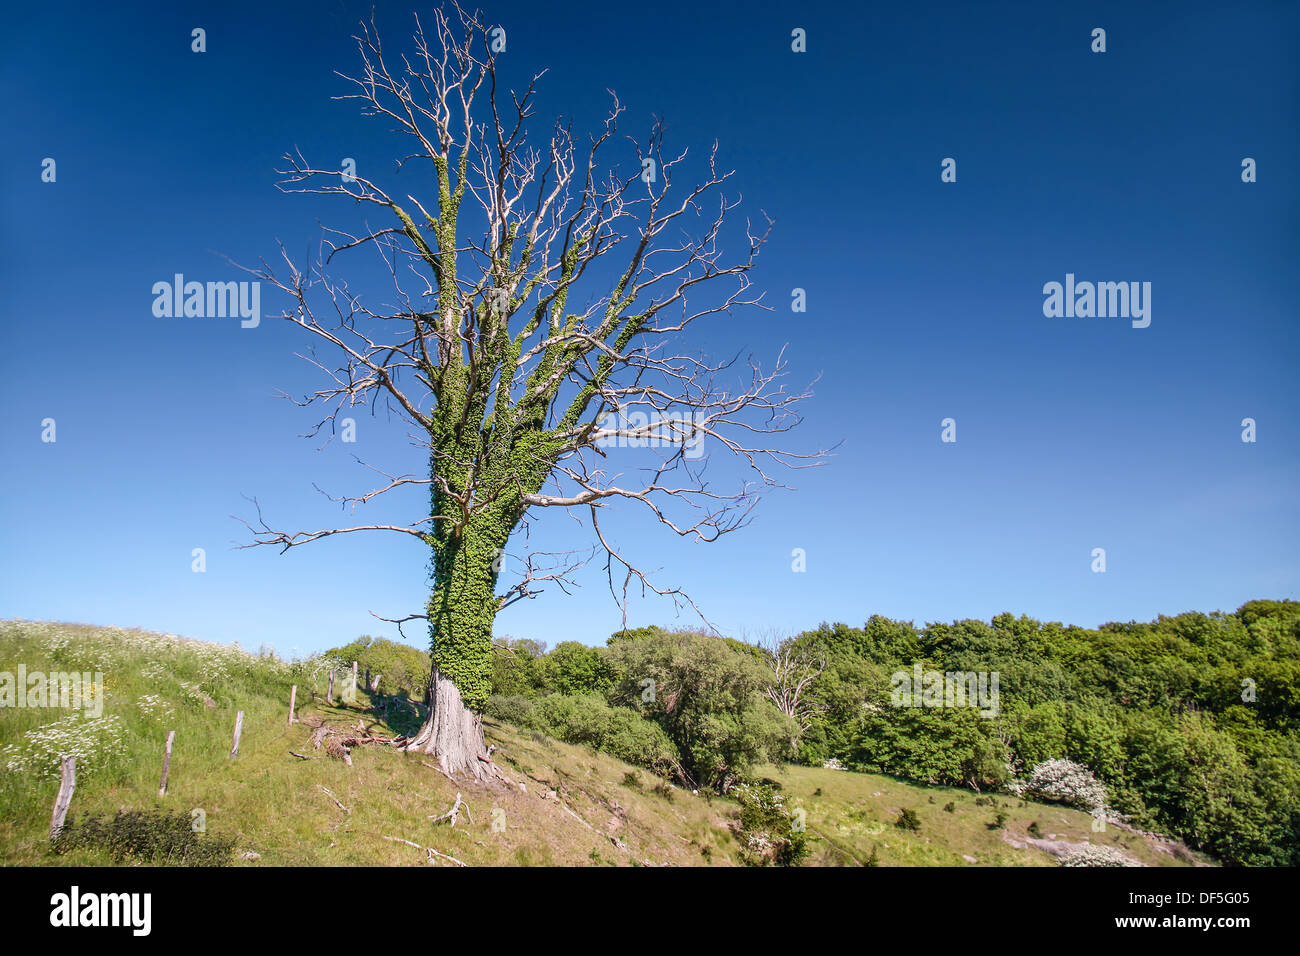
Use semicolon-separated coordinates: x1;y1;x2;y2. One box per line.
236;7;826;779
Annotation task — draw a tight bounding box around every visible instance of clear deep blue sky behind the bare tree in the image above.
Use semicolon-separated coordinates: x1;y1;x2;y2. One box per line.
0;0;1300;653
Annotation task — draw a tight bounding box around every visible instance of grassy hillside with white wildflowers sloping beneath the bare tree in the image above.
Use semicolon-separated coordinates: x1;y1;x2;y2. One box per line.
0;622;1197;866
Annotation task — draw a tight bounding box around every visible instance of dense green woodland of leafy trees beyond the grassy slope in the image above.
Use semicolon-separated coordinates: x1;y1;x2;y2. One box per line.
330;601;1300;866
